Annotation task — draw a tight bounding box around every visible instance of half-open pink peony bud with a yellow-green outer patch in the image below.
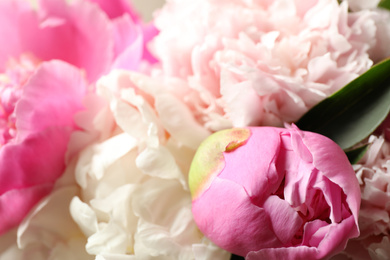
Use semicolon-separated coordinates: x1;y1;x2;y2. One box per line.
189;127;360;260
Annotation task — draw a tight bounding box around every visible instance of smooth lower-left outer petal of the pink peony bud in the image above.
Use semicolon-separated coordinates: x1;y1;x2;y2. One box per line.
192;177;282;256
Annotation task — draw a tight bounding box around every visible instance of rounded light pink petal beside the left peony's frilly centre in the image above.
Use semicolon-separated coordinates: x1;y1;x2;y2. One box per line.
15;61;87;140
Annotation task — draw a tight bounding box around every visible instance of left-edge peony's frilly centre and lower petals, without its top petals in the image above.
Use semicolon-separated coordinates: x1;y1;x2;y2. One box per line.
0;61;87;234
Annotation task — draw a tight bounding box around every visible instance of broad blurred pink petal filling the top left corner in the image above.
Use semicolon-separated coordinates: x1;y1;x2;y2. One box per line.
0;0;113;81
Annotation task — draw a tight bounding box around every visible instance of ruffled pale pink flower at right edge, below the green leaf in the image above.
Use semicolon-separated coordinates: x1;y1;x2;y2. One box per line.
339;135;390;260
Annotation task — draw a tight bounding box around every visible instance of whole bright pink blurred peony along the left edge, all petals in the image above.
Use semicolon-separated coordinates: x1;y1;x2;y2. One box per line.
0;0;156;237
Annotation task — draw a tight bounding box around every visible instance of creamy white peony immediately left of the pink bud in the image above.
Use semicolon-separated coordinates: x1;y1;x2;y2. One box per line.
70;71;230;260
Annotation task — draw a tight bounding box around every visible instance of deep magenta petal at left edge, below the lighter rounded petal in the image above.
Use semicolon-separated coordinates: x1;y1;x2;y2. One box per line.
0;127;71;194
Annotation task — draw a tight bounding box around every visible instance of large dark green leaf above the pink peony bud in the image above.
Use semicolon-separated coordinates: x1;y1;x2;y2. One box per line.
296;59;390;150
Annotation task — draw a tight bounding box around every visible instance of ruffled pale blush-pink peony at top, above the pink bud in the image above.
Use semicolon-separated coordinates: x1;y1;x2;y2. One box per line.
152;0;390;130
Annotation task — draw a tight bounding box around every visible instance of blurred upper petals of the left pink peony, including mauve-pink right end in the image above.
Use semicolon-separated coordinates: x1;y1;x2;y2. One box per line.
0;0;157;81
